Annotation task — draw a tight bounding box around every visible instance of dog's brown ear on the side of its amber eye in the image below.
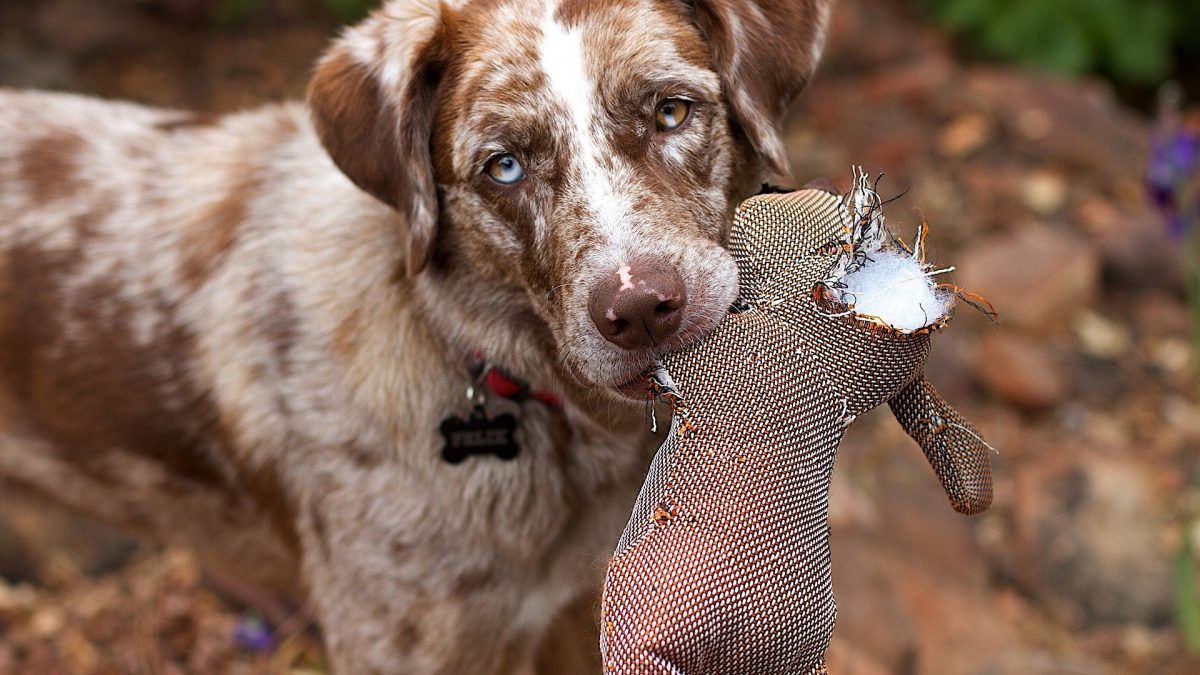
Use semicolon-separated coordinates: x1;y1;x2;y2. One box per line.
689;0;834;175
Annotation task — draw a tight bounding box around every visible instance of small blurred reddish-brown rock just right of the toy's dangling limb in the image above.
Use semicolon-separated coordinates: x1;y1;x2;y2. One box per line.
974;331;1068;411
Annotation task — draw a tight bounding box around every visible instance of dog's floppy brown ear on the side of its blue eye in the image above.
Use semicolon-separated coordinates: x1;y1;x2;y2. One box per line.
308;0;446;275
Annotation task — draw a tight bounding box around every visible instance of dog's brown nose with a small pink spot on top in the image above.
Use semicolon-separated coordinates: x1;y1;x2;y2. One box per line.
588;258;688;350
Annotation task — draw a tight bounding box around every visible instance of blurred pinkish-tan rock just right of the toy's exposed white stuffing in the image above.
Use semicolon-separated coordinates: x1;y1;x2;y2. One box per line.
955;226;1100;334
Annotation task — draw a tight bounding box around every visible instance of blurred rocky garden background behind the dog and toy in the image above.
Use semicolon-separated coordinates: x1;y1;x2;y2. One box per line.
0;0;1200;675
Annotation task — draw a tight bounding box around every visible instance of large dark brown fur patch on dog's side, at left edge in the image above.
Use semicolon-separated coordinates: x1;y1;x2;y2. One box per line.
0;236;228;488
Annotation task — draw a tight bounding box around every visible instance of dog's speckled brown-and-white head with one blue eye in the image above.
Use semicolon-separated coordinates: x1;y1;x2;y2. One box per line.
310;0;833;394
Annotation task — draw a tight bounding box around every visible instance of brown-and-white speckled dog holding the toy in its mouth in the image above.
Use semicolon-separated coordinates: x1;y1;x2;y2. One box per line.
0;0;832;674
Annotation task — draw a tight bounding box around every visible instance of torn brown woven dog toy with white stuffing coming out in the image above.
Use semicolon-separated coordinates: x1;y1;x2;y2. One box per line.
600;173;991;675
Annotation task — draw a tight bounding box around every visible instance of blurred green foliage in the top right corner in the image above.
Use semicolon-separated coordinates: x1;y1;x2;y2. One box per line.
925;0;1200;84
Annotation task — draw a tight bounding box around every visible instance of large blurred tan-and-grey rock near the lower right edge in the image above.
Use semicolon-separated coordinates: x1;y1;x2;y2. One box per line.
1013;447;1175;627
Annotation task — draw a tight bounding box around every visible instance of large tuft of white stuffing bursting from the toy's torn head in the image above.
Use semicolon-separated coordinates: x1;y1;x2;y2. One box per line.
834;250;953;330
